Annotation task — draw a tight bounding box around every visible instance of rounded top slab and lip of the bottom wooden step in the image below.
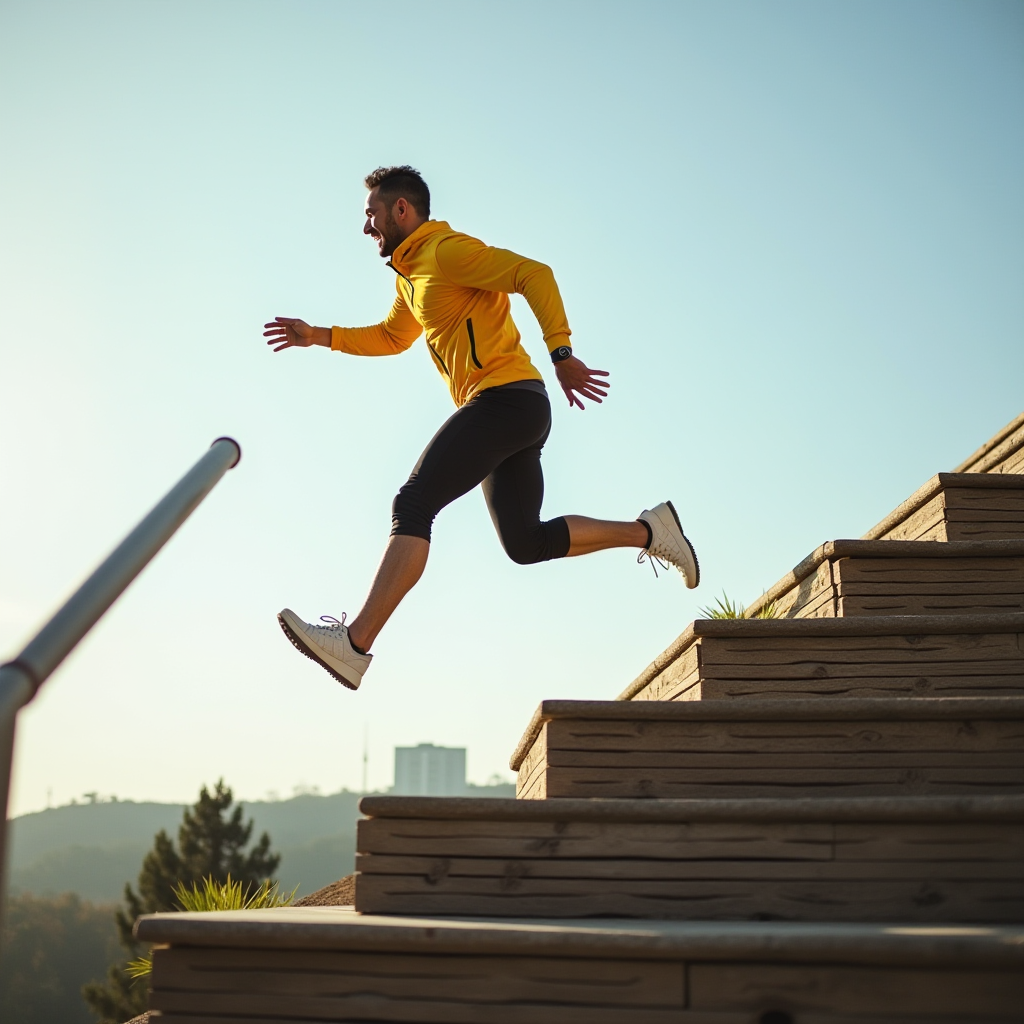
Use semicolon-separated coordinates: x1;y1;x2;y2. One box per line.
135;907;1024;970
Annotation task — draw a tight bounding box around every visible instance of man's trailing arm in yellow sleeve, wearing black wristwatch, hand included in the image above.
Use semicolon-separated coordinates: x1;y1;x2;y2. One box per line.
437;234;611;409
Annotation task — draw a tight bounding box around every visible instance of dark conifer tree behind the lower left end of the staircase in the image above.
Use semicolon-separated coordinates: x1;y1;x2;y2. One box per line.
82;779;281;1024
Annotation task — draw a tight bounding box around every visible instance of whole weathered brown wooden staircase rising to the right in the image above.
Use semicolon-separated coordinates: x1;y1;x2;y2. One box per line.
137;416;1024;1024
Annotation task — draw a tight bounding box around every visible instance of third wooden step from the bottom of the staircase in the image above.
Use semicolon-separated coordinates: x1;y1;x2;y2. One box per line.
511;697;1024;800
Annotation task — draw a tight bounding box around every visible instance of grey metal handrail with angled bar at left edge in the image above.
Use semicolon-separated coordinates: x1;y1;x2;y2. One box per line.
0;437;242;929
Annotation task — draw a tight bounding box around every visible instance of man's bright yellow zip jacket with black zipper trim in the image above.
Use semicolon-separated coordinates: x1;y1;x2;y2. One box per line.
331;220;570;406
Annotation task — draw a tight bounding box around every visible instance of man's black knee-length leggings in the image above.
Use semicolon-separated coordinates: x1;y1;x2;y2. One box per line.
391;385;569;565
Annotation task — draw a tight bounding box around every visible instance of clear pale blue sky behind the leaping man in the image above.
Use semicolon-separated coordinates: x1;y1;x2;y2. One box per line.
0;0;1024;813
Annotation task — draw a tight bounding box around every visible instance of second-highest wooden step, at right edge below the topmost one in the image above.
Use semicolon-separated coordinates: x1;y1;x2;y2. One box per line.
863;471;1024;541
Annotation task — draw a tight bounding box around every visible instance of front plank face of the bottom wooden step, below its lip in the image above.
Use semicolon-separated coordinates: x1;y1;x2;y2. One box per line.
152;933;1024;1024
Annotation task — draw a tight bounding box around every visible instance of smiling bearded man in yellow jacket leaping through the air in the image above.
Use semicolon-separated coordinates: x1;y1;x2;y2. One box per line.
264;166;699;690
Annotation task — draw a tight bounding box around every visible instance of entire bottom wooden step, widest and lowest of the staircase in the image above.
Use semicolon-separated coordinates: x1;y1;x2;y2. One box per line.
136;907;1024;1024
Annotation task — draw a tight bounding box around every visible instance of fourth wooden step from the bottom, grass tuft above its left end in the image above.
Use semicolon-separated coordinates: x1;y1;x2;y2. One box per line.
618;613;1024;700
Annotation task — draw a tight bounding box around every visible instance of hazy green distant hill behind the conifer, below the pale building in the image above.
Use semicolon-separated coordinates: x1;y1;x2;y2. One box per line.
8;783;515;902
